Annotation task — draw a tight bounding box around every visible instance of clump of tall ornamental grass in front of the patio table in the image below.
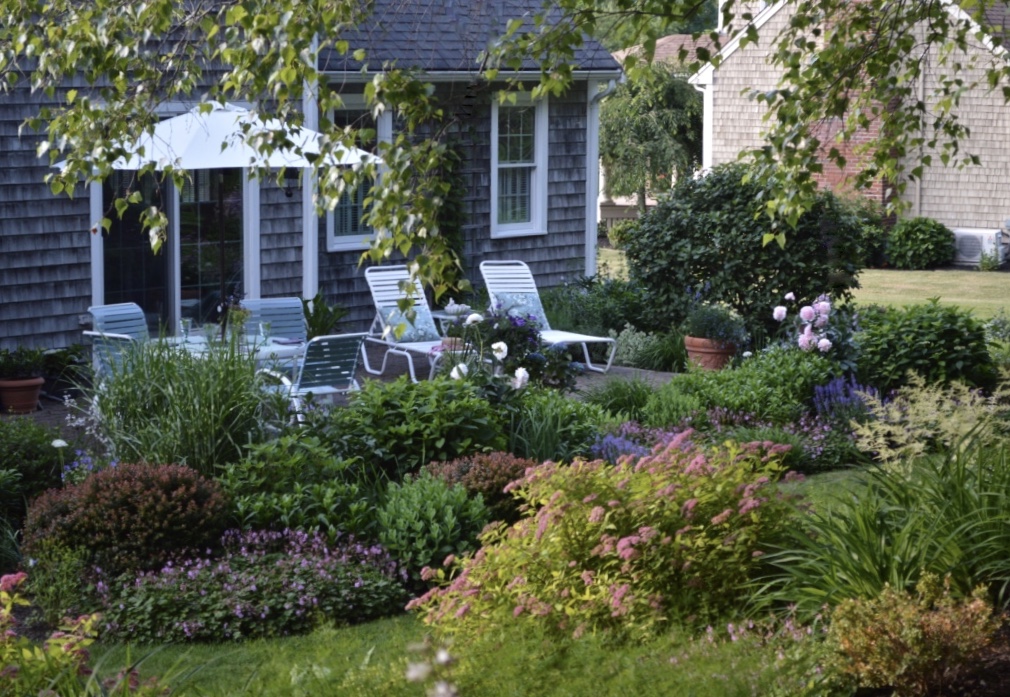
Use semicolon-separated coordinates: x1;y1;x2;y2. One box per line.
79;340;287;475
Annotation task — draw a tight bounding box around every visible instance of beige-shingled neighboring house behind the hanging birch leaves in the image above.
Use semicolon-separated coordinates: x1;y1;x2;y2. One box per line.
691;2;1010;249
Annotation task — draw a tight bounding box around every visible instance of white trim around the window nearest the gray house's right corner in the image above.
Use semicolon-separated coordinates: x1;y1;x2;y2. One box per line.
491;92;549;239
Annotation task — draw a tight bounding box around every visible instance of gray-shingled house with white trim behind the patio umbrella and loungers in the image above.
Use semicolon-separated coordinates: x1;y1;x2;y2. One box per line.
0;0;620;347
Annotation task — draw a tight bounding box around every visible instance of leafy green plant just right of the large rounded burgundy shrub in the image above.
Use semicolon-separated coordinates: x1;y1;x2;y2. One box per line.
219;432;376;540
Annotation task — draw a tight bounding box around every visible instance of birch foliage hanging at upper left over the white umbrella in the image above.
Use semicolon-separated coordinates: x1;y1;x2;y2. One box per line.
0;0;459;295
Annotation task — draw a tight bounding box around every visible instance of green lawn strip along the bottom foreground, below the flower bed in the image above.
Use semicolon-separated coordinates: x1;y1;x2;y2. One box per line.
93;616;812;697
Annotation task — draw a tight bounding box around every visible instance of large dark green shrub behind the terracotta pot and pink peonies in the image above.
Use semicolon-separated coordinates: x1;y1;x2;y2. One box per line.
625;165;860;335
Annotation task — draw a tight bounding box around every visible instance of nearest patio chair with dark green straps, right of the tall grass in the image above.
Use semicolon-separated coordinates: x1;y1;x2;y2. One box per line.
259;332;367;420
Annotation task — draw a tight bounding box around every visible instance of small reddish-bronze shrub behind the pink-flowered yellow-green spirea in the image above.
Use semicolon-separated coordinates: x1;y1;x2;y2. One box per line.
425;453;539;523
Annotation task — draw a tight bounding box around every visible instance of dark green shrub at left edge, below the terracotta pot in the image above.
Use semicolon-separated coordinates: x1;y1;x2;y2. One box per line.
0;416;66;526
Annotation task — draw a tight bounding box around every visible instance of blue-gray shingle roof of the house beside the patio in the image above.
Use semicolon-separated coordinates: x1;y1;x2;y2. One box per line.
319;0;619;73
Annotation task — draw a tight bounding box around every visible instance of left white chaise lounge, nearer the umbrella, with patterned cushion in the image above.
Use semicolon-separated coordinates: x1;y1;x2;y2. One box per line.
362;266;441;383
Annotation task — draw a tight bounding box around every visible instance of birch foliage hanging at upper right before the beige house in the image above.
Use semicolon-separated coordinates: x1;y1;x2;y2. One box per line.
492;0;1010;243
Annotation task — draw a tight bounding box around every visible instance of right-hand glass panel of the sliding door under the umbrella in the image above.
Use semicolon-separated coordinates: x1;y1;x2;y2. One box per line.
179;169;242;324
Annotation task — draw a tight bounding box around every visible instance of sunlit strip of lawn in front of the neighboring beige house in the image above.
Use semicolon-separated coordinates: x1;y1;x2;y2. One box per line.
853;269;1010;319
